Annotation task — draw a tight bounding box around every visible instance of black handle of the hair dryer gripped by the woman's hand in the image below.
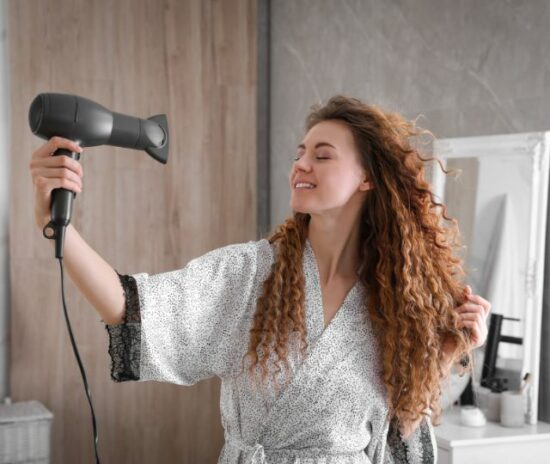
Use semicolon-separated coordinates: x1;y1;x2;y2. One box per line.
43;148;80;258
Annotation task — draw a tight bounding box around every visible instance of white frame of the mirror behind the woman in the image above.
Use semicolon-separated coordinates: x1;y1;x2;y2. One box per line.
432;131;550;424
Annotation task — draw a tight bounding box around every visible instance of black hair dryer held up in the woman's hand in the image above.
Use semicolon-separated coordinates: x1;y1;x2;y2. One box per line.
29;93;168;258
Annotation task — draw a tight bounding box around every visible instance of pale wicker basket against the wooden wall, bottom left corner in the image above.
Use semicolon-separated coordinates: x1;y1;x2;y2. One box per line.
0;401;53;464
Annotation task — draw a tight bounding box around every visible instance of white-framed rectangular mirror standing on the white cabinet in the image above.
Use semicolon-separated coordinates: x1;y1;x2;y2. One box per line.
431;132;550;424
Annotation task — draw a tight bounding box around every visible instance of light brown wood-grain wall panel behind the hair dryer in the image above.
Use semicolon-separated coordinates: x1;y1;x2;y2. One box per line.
8;0;257;464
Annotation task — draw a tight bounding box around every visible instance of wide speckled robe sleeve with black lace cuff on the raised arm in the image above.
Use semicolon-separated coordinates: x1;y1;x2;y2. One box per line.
106;239;271;385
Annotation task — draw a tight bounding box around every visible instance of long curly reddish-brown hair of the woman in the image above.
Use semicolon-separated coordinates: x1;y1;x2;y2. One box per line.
239;95;473;435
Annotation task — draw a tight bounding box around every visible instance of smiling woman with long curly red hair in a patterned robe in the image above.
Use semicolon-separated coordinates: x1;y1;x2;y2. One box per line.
31;96;490;464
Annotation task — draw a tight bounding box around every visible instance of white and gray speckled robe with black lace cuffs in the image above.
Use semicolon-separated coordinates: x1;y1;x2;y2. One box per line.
106;239;437;464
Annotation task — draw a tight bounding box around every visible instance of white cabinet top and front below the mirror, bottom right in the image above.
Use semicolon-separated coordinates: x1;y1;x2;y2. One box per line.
434;406;550;464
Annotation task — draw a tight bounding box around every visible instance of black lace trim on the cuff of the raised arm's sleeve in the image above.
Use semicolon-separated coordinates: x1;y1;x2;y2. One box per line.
105;271;141;382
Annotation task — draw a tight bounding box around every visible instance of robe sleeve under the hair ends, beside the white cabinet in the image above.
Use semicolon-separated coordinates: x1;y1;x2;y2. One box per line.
365;409;437;464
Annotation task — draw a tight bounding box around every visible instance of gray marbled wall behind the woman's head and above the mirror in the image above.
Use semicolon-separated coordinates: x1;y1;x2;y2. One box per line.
270;0;550;421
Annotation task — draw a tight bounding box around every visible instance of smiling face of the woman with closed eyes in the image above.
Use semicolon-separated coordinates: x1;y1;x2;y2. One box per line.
289;120;371;214
